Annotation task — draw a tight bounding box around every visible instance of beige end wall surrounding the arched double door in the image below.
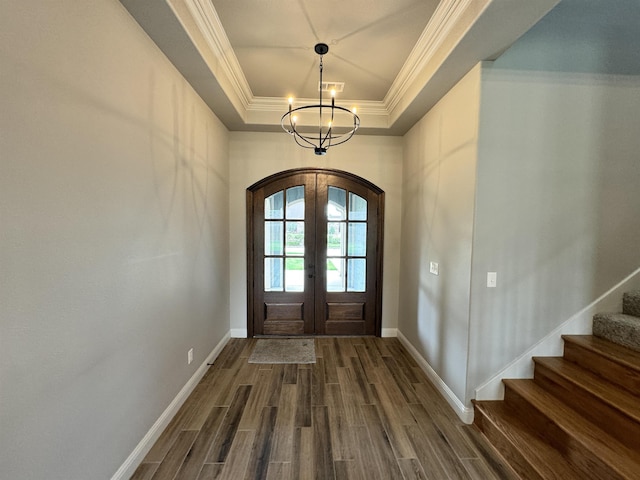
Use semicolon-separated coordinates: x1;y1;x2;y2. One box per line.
229;129;402;336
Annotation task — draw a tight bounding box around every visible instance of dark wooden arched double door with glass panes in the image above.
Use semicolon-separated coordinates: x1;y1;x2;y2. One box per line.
247;169;384;336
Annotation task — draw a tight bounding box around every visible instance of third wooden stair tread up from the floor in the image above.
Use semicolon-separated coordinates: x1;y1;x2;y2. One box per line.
533;357;640;422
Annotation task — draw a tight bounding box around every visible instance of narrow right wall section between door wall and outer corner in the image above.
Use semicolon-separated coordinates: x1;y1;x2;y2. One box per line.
398;62;480;413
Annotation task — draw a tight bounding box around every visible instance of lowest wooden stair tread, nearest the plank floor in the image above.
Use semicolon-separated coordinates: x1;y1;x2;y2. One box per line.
474;400;584;480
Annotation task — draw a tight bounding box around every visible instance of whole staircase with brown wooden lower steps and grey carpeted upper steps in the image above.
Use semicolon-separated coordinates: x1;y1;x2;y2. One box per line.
474;291;640;480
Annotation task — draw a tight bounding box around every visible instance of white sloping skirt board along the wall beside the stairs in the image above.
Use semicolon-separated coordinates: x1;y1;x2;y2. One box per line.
474;268;640;400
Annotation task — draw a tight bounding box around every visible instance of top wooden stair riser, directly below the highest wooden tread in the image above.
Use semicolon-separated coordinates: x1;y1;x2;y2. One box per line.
564;342;640;396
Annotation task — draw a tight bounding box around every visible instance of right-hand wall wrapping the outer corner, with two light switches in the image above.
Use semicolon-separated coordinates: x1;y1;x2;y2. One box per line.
398;62;640;418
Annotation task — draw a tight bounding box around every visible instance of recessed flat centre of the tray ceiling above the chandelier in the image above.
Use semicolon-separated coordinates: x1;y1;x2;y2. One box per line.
212;0;438;101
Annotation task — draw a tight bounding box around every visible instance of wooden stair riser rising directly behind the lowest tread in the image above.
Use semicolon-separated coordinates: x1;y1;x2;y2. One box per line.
504;386;623;480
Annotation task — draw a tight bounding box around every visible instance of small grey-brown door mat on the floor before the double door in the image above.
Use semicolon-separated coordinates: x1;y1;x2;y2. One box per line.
249;338;316;363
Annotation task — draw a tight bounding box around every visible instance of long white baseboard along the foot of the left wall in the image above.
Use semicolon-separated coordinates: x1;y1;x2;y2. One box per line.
111;333;231;480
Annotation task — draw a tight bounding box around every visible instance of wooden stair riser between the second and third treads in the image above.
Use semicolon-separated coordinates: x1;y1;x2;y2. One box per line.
534;364;640;451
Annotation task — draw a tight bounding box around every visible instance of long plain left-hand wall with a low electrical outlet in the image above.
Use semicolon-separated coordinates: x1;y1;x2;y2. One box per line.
0;0;229;480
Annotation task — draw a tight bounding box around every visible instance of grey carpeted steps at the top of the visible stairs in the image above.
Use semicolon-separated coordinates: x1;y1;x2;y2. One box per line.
593;290;640;352
